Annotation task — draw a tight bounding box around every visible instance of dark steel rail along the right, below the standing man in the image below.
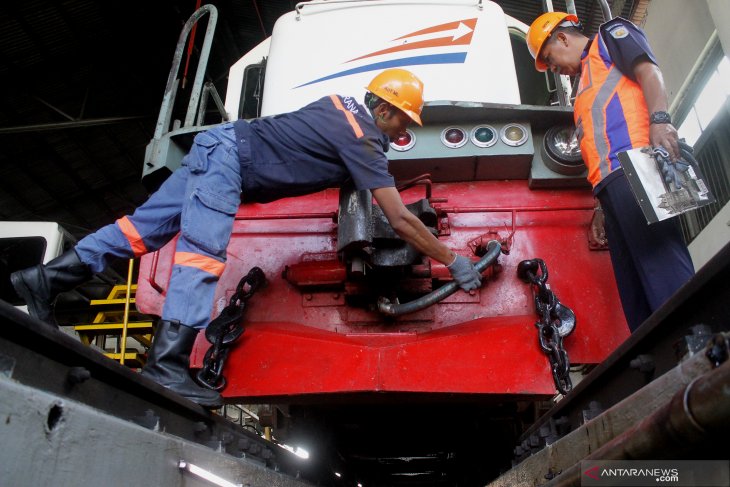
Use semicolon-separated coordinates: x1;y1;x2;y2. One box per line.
495;244;730;474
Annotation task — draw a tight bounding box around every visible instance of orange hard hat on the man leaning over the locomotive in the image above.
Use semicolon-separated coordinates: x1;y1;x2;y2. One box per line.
366;68;423;125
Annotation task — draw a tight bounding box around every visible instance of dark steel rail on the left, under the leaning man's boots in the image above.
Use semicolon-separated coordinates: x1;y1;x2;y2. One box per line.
0;300;319;482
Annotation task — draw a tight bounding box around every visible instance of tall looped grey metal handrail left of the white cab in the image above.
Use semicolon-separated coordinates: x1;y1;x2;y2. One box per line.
154;5;218;139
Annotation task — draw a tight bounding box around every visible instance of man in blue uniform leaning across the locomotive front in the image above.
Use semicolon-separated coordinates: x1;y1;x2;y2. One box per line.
11;69;481;407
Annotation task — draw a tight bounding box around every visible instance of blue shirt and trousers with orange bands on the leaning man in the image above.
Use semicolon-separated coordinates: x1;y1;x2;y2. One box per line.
75;95;394;328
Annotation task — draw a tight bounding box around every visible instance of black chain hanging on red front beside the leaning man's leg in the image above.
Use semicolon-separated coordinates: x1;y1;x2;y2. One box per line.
196;267;266;391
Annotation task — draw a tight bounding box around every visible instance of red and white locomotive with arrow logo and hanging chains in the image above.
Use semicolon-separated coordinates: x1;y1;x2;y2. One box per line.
136;0;629;485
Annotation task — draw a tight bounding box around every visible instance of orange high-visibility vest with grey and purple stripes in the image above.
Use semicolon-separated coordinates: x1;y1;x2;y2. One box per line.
573;31;649;188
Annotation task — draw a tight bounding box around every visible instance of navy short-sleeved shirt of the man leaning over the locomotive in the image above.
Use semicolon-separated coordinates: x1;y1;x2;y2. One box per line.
234;95;395;203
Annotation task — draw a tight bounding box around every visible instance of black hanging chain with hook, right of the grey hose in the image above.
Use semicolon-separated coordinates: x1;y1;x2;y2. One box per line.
517;259;575;395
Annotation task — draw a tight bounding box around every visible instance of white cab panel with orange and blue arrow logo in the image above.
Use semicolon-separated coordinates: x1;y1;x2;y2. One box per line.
256;0;520;115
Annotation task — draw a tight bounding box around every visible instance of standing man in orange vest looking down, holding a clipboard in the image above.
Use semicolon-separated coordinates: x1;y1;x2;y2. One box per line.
527;12;694;332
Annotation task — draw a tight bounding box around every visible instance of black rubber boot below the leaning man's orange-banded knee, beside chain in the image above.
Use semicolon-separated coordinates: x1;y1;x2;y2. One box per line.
142;320;223;409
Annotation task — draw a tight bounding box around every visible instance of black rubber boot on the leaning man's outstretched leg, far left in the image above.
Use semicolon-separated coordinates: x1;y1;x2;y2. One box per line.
10;249;93;327
